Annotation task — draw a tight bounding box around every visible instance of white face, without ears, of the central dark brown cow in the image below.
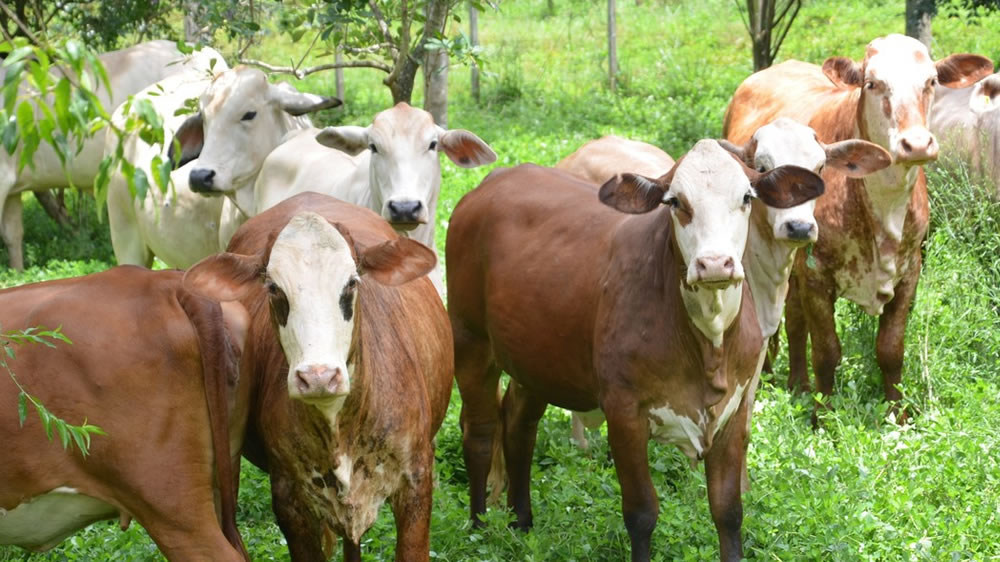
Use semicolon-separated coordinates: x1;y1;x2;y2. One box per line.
664;140;753;282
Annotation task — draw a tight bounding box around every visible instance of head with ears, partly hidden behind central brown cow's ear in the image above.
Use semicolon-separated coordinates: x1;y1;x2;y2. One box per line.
719;117;892;247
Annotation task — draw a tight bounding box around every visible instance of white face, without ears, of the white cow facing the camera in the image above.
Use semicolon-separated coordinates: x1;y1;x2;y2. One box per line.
368;106;443;230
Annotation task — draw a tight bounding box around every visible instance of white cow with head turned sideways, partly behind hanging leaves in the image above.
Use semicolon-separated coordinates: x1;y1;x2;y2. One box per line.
107;64;341;268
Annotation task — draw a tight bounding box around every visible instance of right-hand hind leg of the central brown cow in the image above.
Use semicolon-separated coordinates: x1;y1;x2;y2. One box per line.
503;379;548;531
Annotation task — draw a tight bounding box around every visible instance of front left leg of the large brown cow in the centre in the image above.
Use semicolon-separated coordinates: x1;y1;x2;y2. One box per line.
601;389;660;562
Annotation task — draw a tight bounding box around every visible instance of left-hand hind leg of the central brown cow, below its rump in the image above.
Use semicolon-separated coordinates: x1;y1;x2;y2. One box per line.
452;321;500;526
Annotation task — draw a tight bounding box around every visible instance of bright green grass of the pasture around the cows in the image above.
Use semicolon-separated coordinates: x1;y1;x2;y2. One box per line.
0;0;1000;561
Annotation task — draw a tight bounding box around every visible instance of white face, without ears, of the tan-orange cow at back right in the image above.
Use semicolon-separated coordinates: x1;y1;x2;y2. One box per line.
861;34;938;164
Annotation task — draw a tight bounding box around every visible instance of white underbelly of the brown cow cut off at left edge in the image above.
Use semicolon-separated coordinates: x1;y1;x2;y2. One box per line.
0;487;118;551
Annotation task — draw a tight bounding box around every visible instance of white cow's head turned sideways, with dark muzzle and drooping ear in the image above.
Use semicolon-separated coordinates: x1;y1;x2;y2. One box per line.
171;66;341;194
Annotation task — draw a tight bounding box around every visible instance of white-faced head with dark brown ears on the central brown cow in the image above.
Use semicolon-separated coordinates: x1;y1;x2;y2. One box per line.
599;140;823;289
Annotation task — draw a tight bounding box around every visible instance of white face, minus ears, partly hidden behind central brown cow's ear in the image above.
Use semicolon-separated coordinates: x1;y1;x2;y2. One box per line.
753;117;826;245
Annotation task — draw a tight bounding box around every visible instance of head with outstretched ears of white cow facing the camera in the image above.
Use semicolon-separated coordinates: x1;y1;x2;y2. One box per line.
316;102;497;230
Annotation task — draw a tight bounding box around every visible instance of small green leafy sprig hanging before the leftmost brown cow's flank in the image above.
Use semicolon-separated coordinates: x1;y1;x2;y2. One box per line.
0;327;107;457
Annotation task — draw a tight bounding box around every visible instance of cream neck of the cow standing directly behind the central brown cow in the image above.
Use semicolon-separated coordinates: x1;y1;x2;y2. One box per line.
743;199;796;338
